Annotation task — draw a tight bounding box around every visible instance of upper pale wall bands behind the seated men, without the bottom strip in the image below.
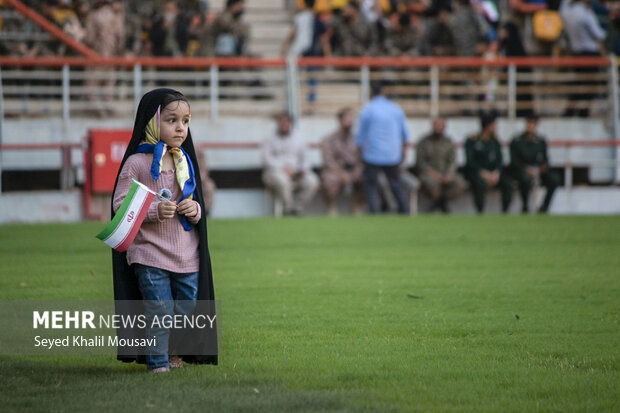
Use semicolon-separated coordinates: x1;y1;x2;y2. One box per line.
1;117;615;183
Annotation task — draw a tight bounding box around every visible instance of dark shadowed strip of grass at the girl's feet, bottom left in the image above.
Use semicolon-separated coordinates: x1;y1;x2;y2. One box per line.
0;356;385;412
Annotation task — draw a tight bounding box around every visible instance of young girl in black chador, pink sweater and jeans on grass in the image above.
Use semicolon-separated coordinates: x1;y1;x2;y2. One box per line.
112;89;217;373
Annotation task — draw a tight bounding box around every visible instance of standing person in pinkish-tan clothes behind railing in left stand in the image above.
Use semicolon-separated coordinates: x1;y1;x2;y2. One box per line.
85;0;125;117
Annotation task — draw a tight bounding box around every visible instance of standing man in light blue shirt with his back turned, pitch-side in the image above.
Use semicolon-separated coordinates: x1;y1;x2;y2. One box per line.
355;85;409;214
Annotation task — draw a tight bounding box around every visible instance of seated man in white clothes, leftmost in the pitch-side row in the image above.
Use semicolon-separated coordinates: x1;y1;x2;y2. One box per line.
262;112;319;215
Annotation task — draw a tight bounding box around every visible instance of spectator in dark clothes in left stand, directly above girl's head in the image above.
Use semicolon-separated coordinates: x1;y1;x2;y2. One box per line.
150;0;188;57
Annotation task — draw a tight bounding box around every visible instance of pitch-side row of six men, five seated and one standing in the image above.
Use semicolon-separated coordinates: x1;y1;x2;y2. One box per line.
262;85;559;215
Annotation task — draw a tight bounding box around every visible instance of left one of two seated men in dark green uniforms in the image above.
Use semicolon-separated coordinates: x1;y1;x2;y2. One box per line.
465;114;513;213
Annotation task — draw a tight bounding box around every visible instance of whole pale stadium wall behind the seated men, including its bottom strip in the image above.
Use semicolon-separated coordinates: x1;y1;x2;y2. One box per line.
0;117;620;223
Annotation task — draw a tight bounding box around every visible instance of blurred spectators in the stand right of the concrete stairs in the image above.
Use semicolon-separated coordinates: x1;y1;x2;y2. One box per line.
282;0;620;57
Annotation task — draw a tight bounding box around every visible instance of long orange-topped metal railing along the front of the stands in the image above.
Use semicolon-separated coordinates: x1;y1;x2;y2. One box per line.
0;56;620;182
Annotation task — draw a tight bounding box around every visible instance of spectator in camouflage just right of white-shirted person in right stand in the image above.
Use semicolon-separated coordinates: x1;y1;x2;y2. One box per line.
321;2;378;56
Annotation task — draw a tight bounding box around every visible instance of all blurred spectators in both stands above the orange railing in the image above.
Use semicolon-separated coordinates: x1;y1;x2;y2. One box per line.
0;0;620;57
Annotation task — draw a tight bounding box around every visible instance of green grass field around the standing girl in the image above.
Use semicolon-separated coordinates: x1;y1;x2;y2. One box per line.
0;216;620;412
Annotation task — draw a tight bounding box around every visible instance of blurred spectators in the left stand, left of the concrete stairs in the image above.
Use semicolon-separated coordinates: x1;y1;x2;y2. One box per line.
0;0;249;57
